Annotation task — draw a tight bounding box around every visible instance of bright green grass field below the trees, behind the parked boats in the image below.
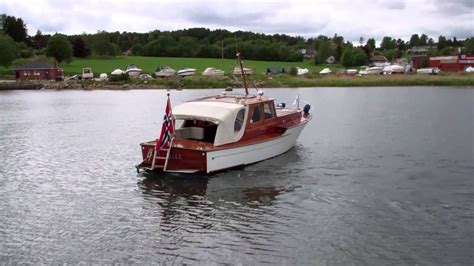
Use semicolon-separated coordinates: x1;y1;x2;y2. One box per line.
0;56;340;76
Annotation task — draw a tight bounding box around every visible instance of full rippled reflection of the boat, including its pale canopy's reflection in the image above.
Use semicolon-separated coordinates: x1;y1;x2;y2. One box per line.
138;146;305;236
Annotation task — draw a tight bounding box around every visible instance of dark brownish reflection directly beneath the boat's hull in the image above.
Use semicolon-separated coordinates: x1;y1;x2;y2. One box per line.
138;147;308;207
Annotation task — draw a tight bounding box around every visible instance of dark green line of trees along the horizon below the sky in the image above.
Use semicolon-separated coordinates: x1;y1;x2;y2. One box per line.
0;13;474;66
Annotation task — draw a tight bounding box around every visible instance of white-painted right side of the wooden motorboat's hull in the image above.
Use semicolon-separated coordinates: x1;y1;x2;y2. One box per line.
206;120;309;173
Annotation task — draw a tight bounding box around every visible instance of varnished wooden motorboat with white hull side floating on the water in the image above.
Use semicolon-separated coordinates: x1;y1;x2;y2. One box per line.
136;54;311;173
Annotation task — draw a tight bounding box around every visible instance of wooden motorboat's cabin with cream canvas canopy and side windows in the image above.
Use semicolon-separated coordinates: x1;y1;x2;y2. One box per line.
173;96;276;146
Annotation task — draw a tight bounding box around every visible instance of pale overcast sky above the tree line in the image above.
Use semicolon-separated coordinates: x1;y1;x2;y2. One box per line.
0;0;474;41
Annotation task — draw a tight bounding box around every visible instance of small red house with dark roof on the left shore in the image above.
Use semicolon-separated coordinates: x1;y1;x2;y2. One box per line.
14;62;63;80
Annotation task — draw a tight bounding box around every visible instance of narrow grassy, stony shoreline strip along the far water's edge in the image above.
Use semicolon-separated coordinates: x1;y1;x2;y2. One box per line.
0;73;474;91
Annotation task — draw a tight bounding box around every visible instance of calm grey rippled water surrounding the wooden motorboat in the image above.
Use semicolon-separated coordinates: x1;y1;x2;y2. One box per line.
0;87;474;265
